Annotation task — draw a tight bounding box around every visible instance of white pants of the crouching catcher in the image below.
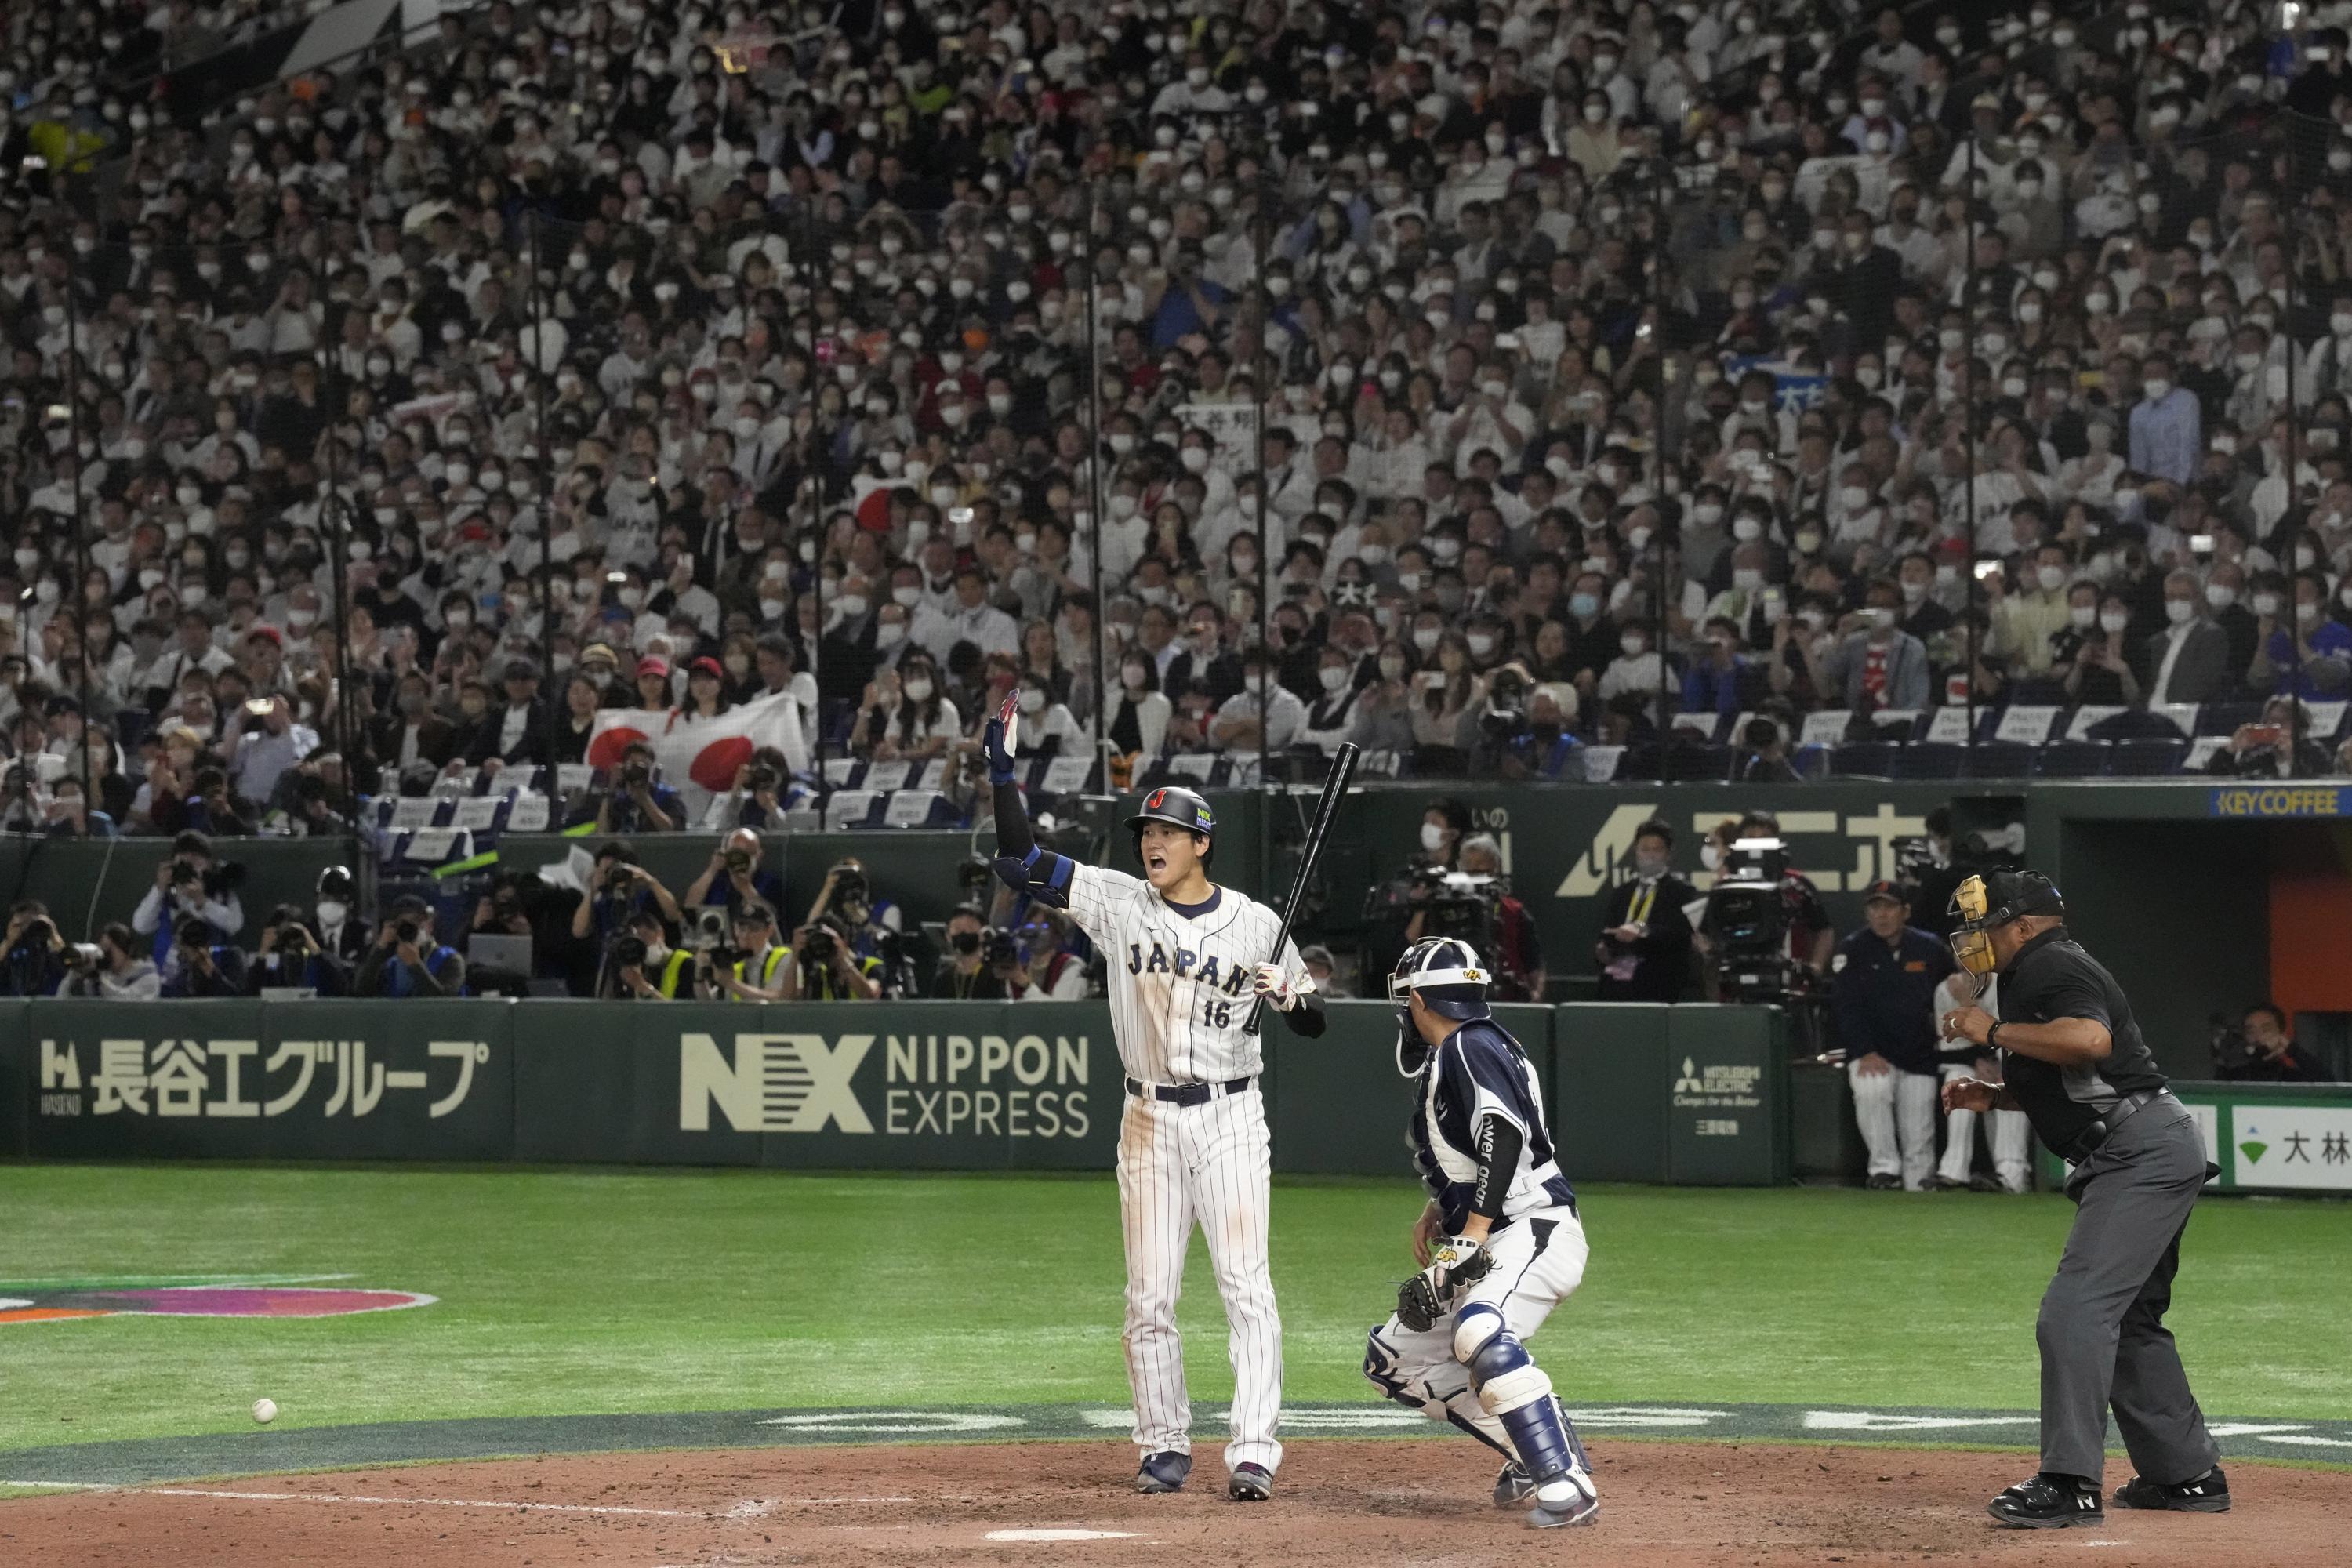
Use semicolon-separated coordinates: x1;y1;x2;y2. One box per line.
1364;1208;1590;1455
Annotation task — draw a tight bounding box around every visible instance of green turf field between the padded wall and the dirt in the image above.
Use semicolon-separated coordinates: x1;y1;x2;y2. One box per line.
0;1166;2352;1450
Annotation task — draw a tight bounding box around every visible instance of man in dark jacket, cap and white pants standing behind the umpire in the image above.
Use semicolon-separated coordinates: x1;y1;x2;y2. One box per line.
1830;881;1952;1192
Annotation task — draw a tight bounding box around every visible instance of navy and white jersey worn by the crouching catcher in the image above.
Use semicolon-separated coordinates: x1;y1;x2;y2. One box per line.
1406;1018;1576;1234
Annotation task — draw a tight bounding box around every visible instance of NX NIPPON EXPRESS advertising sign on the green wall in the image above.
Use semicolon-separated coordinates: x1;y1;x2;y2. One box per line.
677;1029;1091;1140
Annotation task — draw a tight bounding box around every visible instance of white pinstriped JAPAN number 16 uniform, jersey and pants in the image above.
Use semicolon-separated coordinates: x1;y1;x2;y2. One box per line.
1070;865;1305;1472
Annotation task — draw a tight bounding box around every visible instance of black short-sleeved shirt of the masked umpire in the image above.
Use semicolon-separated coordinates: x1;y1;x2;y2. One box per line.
2002;926;2166;1156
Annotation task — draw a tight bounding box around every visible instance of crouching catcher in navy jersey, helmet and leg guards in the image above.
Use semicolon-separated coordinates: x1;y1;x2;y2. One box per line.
1364;938;1602;1530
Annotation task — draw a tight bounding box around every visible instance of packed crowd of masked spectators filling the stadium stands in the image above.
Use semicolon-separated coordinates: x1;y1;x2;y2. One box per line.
0;0;2352;837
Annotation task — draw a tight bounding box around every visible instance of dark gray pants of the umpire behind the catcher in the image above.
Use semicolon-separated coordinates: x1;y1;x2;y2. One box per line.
2034;1100;2220;1486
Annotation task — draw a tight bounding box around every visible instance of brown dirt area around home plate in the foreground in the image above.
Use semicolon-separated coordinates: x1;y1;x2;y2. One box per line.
0;1439;2352;1568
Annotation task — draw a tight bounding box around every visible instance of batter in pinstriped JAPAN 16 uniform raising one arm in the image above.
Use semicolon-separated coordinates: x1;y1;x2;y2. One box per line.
985;703;1324;1502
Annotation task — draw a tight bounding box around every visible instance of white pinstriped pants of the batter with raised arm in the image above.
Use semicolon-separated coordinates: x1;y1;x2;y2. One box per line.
1120;1083;1282;1472
